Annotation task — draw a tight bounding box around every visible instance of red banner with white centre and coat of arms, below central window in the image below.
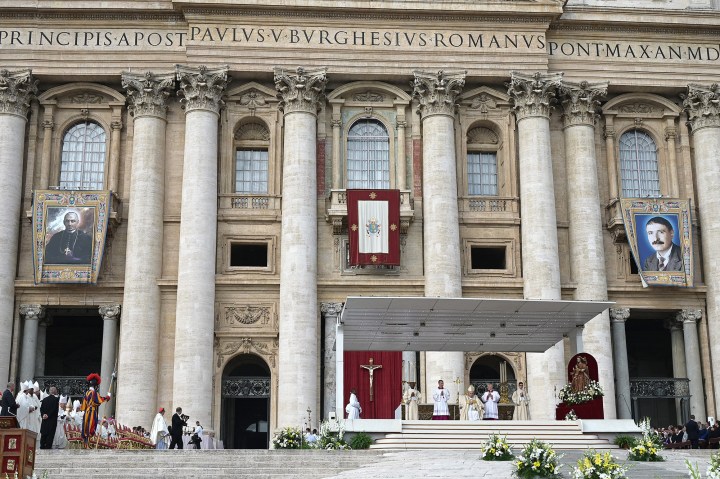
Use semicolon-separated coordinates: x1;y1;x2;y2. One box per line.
347;190;400;266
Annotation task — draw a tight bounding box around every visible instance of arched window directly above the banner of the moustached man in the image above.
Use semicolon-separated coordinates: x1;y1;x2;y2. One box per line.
620;130;660;198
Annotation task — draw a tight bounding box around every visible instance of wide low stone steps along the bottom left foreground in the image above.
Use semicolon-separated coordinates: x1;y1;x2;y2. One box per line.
35;449;383;479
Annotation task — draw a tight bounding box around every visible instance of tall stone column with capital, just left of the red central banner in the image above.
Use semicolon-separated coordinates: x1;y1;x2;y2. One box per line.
275;68;327;427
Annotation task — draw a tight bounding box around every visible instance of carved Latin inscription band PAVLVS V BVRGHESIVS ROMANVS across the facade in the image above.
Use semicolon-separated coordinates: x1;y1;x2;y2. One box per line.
0;26;720;62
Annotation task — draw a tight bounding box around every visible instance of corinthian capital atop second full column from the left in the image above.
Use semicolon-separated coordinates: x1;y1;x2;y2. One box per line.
122;72;175;119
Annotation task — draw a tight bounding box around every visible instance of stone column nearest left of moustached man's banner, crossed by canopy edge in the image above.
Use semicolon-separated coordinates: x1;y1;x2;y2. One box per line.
560;81;616;419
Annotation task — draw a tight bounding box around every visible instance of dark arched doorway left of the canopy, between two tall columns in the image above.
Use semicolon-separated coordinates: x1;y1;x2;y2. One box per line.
220;354;270;449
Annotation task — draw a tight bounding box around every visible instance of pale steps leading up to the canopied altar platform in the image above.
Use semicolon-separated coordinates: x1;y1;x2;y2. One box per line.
370;421;618;451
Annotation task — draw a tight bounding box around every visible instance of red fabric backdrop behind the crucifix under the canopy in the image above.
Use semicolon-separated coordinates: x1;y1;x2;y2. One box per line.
343;351;402;419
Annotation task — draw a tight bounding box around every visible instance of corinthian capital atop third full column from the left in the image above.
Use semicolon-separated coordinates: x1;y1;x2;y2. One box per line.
176;65;229;113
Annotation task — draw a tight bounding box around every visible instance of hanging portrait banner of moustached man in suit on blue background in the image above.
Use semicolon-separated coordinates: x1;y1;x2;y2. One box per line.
621;198;695;288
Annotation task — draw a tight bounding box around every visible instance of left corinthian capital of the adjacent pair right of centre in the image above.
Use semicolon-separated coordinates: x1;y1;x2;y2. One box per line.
508;72;562;121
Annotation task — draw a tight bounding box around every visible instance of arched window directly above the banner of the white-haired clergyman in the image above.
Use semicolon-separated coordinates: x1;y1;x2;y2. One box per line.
60;121;105;190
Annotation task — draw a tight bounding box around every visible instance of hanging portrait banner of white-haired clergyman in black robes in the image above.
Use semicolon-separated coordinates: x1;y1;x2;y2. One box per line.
32;190;112;284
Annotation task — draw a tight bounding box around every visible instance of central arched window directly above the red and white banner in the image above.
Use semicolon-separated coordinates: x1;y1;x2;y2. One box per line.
347;119;390;189
